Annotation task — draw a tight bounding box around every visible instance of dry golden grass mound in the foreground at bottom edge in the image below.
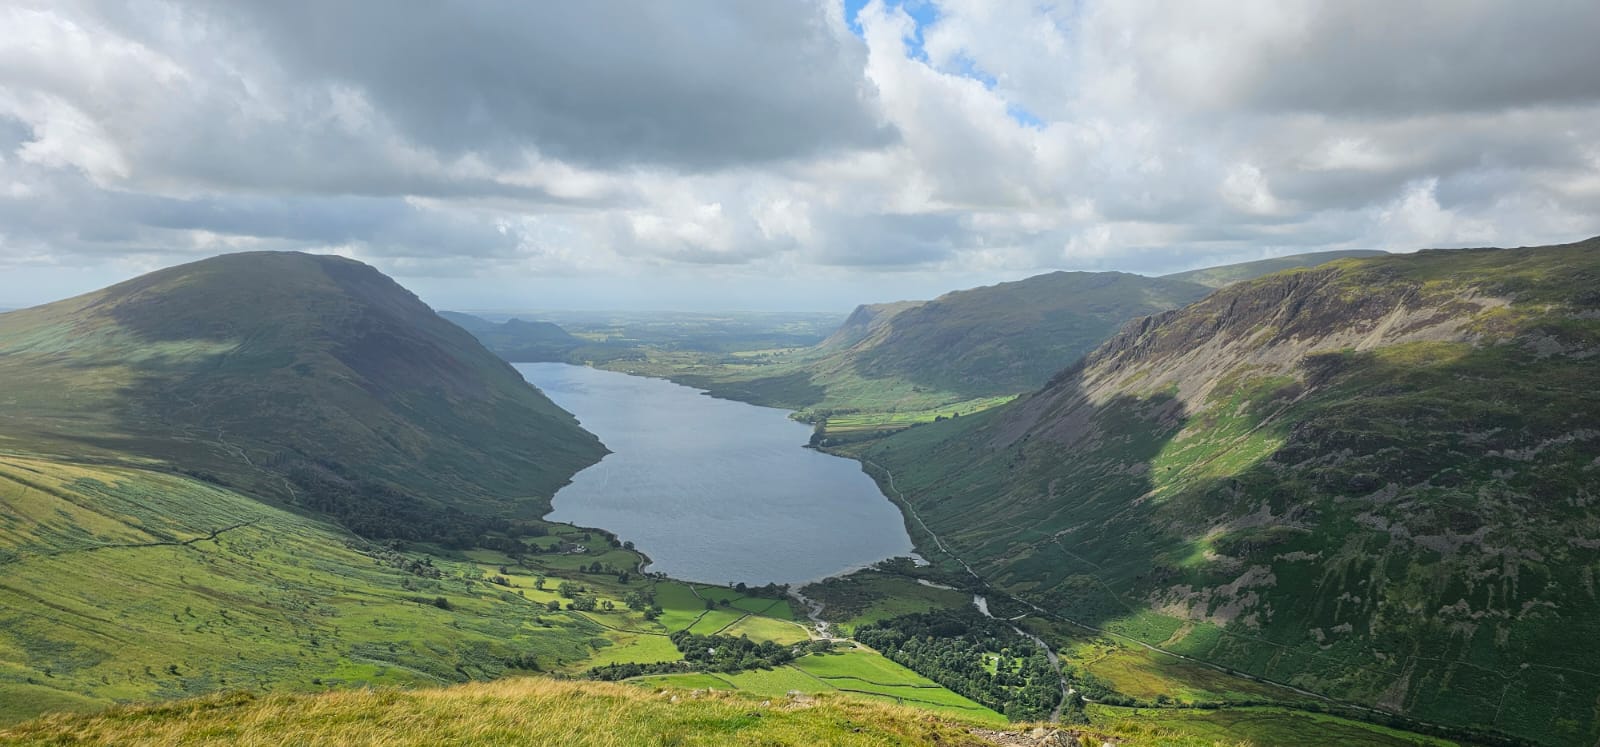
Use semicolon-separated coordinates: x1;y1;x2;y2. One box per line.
0;678;992;747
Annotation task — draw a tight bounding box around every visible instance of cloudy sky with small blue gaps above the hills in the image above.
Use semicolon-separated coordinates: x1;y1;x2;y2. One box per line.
0;0;1600;310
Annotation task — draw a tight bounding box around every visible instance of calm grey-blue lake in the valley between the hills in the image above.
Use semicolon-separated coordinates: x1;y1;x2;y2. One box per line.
517;363;912;584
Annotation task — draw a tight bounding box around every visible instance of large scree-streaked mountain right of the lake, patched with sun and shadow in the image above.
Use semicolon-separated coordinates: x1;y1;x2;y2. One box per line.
864;238;1600;744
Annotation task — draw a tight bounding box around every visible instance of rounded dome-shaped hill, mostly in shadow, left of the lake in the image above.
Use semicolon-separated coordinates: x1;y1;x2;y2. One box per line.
0;253;605;537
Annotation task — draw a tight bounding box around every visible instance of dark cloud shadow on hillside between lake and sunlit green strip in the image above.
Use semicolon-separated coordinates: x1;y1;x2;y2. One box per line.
869;368;1189;627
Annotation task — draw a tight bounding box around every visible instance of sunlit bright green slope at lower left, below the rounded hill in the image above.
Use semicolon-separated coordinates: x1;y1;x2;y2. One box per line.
0;456;610;721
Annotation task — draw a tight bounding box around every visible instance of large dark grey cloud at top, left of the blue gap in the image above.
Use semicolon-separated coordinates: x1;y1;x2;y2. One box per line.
211;0;893;170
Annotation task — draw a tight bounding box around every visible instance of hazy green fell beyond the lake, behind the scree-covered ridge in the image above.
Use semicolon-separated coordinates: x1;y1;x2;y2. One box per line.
681;272;1210;419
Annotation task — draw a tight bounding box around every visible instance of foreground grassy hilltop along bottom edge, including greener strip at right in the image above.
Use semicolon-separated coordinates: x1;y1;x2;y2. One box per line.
0;675;1453;747
